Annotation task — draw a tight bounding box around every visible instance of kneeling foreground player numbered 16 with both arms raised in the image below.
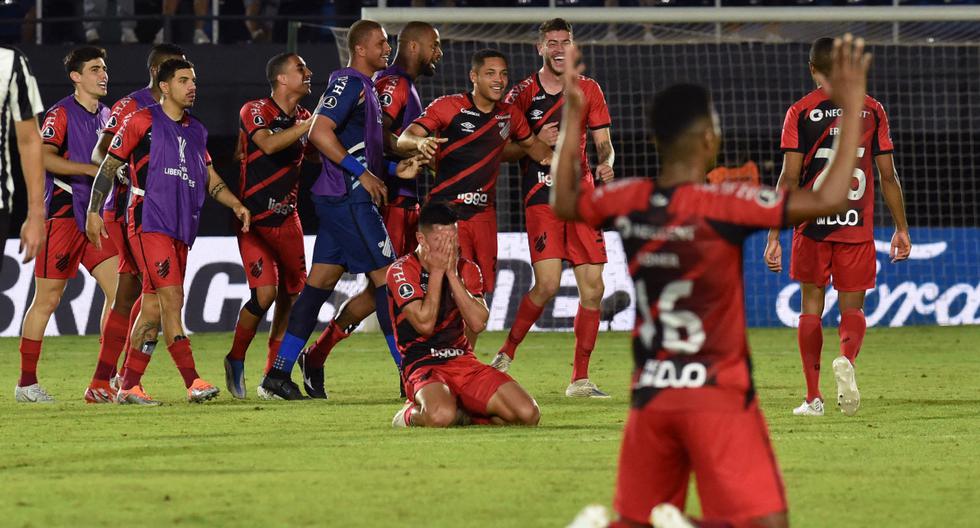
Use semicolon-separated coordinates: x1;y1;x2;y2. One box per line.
552;35;870;527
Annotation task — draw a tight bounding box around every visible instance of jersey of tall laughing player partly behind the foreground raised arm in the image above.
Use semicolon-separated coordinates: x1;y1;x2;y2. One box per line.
504;73;612;207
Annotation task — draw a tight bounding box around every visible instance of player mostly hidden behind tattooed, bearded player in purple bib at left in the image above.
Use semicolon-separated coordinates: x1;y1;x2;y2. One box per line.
85;44;184;403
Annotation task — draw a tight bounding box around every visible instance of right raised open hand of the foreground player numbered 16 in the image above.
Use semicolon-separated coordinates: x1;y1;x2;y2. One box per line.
817;33;871;109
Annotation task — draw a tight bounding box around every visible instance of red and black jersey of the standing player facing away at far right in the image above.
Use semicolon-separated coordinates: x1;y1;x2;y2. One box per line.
780;88;894;243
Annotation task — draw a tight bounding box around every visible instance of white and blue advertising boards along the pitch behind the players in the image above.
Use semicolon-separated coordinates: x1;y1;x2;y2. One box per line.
0;228;980;336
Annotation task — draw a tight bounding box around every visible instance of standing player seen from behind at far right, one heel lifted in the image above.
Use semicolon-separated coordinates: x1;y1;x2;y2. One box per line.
764;38;912;416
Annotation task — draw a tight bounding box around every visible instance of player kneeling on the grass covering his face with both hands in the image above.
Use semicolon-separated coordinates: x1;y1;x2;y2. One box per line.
388;202;541;427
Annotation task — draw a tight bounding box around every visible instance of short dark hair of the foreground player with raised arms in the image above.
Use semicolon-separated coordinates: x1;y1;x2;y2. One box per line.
650;84;711;147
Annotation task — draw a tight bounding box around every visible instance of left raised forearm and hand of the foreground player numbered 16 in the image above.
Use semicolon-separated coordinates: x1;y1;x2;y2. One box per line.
551;45;585;220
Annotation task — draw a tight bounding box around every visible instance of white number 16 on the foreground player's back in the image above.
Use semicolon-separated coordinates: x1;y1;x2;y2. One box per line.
636;279;705;354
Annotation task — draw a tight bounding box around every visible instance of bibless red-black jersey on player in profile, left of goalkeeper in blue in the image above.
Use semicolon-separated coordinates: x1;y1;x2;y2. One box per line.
238;97;310;227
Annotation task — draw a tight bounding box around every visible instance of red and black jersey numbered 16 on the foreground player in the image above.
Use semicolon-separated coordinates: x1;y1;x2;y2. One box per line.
577;178;786;410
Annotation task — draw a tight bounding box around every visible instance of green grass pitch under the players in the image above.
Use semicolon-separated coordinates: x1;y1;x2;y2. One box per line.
0;327;980;527
